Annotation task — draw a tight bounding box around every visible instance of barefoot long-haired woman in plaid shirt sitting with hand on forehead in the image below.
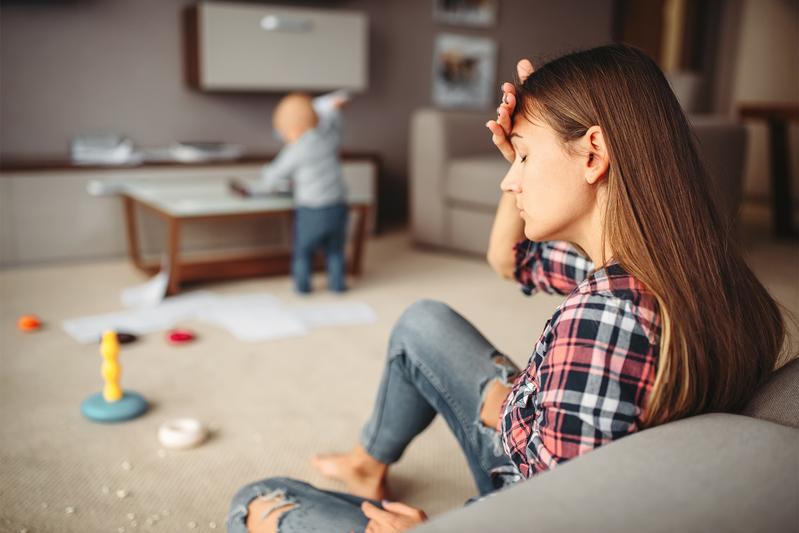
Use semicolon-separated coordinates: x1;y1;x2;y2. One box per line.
229;45;784;533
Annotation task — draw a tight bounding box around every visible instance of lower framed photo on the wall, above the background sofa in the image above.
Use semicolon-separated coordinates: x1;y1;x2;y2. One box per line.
433;33;497;109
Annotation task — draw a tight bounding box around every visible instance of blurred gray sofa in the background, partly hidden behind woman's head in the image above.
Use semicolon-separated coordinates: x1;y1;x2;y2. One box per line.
409;109;746;255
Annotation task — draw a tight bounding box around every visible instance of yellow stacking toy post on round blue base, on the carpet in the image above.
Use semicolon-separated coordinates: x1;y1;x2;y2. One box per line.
80;331;147;422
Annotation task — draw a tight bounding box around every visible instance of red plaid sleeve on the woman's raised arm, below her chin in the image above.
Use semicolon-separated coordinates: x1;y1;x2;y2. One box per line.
513;240;594;296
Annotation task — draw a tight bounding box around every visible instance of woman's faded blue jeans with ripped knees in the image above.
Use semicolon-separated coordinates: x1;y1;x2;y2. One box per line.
228;300;519;533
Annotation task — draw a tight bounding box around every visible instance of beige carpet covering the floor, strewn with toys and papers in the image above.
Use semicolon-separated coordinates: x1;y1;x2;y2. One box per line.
0;225;799;533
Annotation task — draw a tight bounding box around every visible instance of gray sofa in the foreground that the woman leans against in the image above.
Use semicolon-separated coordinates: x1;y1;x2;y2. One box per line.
414;360;799;533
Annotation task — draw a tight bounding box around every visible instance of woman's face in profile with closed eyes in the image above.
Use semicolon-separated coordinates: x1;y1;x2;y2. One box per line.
500;114;594;241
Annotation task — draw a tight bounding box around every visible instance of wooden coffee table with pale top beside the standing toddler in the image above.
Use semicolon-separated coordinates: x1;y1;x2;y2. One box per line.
118;178;372;294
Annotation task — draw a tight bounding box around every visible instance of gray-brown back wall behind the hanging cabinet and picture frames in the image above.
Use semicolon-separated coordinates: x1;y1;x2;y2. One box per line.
0;0;612;223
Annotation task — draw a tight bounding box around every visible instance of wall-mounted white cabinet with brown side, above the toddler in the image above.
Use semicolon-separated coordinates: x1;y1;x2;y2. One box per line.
184;2;368;91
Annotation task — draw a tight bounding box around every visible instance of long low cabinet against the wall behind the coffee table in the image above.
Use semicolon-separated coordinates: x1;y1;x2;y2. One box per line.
0;154;379;268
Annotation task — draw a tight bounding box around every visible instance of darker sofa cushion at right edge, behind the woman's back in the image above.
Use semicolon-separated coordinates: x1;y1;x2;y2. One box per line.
743;359;799;428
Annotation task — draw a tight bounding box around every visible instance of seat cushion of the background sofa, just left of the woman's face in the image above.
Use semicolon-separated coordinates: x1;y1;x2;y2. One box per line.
444;155;508;207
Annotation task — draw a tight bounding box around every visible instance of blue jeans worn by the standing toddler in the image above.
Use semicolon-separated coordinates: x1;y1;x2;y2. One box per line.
291;203;348;293
